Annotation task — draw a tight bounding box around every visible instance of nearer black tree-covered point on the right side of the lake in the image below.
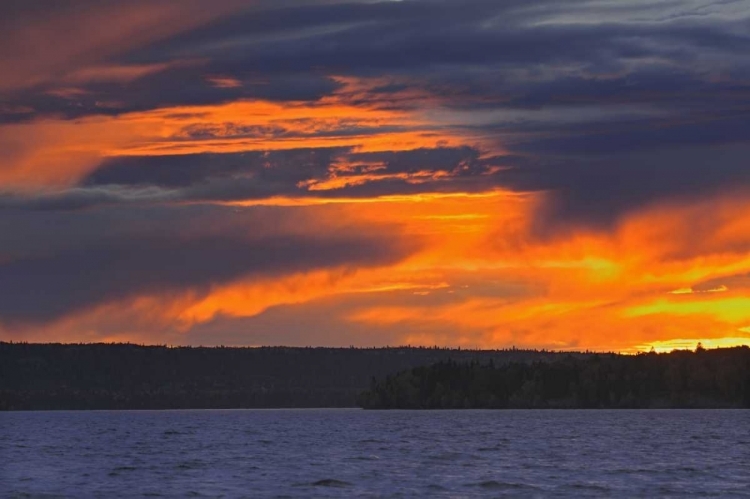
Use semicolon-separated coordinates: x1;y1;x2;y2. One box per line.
357;347;750;409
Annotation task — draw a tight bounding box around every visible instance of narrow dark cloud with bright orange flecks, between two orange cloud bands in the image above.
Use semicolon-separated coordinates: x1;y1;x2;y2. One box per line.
72;147;510;208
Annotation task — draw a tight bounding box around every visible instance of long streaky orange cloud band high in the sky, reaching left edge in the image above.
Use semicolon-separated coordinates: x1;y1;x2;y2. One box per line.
0;91;467;191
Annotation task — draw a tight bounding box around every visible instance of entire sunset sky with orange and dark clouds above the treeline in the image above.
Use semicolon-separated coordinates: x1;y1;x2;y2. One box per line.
0;0;750;352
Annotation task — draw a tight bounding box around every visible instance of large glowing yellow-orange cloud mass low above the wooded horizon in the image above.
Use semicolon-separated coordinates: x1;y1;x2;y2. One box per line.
5;191;750;352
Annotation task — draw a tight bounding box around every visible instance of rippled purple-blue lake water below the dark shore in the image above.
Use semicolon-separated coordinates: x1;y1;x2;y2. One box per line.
0;409;750;497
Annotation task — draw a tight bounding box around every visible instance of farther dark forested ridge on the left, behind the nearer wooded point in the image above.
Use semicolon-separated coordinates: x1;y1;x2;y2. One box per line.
0;342;560;410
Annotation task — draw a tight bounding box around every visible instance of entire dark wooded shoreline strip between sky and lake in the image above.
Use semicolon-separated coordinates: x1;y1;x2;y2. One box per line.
0;342;750;411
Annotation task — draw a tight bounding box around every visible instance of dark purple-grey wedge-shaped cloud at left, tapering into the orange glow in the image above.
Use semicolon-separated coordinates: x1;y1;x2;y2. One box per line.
0;203;414;324
